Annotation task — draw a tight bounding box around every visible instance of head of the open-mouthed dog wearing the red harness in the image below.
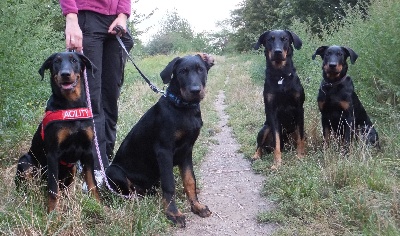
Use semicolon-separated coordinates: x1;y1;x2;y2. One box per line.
39;52;96;100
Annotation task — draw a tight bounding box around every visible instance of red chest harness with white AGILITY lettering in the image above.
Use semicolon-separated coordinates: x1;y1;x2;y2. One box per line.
41;108;93;140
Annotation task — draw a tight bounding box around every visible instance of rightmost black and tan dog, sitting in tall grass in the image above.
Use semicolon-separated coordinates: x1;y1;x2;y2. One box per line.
312;46;379;148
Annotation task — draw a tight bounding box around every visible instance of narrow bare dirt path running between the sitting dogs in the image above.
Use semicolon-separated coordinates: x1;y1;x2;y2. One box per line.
175;91;275;236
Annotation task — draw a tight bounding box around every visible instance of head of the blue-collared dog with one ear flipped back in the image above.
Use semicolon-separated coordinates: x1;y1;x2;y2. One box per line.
160;53;214;102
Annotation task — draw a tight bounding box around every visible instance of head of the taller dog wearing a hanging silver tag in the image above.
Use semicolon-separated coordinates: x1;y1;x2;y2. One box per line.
254;30;302;69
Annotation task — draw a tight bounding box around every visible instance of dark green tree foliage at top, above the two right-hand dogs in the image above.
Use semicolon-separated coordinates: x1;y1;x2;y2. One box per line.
231;0;369;51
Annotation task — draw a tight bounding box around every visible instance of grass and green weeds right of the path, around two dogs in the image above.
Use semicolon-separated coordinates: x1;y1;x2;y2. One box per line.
222;0;400;235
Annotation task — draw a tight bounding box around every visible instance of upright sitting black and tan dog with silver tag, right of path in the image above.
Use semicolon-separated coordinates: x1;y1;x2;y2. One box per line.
253;30;305;169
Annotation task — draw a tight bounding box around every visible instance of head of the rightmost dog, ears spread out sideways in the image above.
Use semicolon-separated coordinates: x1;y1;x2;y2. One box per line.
312;45;358;80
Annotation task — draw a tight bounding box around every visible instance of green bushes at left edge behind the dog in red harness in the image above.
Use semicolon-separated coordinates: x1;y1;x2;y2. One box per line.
0;0;64;163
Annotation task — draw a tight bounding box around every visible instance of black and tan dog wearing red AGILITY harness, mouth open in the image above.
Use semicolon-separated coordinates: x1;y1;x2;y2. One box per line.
15;52;99;212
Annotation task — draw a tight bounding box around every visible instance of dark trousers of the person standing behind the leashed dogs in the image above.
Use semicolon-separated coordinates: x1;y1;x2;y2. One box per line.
78;11;133;170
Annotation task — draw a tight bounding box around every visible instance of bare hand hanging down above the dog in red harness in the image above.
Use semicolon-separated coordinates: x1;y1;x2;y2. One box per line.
65;13;83;52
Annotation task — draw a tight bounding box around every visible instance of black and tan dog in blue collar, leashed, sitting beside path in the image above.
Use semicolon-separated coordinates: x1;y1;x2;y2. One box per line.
106;54;214;227
